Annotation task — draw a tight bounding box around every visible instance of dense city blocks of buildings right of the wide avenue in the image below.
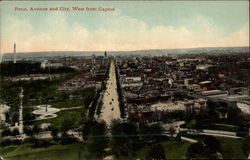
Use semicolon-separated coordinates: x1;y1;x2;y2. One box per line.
116;54;250;119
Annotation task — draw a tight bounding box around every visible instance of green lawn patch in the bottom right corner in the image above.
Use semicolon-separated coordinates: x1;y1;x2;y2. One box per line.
217;137;247;159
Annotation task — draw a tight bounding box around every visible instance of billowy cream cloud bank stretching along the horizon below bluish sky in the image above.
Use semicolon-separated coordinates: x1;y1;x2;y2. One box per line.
1;13;249;52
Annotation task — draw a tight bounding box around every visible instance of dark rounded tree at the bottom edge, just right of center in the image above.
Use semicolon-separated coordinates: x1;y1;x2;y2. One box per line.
146;144;166;160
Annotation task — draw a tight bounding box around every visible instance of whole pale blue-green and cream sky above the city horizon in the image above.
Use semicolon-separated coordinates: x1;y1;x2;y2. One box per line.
0;1;249;53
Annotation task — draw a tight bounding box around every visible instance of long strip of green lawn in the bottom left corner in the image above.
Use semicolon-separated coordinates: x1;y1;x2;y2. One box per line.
0;143;86;160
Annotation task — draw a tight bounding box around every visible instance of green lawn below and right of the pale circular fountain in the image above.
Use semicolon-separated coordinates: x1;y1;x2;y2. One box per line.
35;108;83;128
